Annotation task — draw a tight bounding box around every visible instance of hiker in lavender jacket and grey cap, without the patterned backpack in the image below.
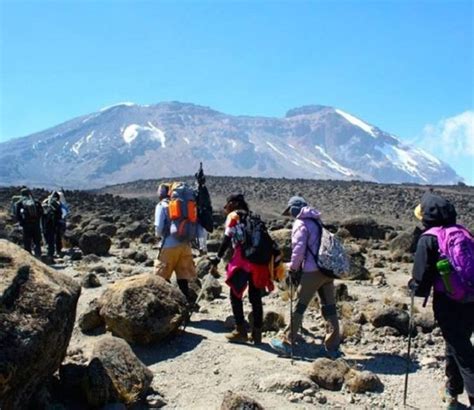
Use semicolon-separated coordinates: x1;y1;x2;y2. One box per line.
270;196;341;357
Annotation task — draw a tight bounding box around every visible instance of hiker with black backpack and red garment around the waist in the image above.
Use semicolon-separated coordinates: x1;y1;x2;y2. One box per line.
211;194;273;344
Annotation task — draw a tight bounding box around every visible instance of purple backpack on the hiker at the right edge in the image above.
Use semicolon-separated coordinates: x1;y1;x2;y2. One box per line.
423;225;474;301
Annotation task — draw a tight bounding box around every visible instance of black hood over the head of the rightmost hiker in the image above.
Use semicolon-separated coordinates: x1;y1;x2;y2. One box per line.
421;192;457;228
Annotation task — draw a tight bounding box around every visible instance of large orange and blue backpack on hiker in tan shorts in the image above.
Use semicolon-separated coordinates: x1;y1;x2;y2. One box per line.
168;182;197;241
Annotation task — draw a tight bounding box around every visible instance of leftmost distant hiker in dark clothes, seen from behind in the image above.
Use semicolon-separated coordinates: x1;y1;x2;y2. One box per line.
15;188;43;258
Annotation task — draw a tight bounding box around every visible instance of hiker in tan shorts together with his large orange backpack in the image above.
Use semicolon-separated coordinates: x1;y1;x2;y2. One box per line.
155;183;197;303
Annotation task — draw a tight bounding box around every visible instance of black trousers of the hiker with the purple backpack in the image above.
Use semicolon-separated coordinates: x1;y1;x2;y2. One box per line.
433;292;474;404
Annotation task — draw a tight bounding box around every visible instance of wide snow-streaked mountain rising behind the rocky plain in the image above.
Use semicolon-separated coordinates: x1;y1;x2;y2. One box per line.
0;102;462;188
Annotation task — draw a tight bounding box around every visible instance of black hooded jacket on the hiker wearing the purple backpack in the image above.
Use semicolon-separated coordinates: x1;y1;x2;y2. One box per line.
412;193;457;297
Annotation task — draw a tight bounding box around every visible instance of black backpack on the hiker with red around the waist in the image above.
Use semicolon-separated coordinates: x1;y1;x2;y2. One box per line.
237;211;275;265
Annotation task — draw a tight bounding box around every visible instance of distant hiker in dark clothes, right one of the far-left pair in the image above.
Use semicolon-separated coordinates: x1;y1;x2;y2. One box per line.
42;191;63;263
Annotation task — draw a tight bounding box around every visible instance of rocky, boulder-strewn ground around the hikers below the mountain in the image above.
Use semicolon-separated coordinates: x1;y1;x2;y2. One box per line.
0;178;474;409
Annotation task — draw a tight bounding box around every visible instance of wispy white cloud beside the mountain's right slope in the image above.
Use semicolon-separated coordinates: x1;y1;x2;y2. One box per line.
418;110;474;159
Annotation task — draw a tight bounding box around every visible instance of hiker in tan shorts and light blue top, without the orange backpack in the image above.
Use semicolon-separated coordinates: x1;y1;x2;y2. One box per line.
155;184;197;304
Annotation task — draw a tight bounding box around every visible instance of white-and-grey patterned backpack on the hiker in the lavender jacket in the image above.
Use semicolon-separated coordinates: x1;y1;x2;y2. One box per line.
308;220;350;279
